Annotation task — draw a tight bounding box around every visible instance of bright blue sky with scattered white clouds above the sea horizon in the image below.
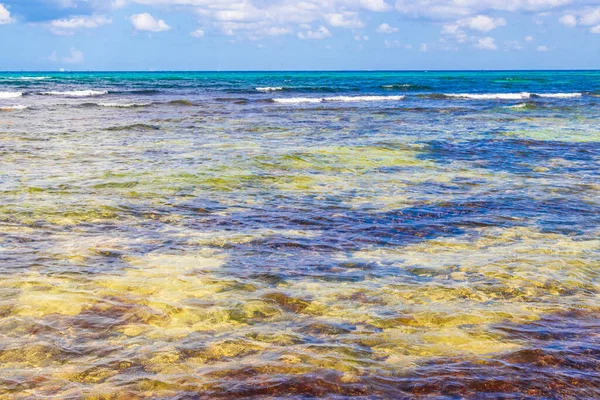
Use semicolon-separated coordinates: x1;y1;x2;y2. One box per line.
0;0;600;71
